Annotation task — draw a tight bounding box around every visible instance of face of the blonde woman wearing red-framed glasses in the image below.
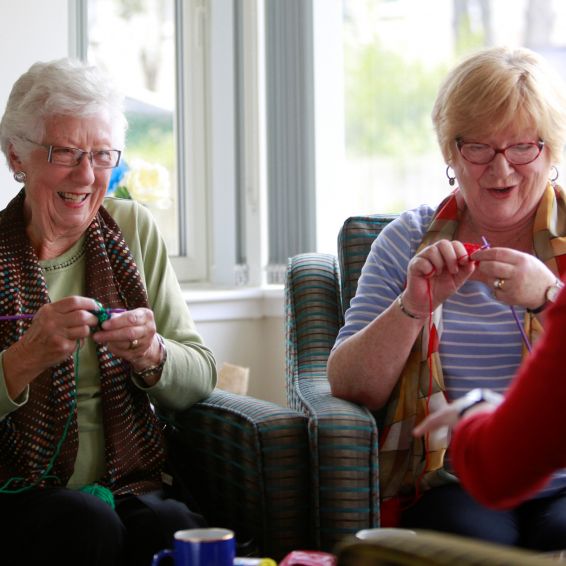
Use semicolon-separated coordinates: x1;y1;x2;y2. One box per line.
451;127;551;230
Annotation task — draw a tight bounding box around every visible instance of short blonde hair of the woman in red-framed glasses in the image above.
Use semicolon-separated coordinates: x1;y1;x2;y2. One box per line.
432;47;566;164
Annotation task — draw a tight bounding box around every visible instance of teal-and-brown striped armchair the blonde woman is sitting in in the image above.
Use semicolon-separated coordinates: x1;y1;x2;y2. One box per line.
286;215;393;550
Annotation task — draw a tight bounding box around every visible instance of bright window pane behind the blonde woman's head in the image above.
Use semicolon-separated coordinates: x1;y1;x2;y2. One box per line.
317;0;566;253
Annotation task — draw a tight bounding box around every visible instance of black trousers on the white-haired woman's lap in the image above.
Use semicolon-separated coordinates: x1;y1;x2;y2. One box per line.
0;488;209;566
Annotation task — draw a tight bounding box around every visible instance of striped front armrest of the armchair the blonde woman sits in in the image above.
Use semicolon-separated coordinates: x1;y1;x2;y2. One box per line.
297;375;379;551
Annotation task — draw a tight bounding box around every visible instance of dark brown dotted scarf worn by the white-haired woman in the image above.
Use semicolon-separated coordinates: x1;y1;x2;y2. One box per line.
0;190;164;495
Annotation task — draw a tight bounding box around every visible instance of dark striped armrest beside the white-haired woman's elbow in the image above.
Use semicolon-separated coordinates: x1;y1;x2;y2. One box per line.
162;389;310;560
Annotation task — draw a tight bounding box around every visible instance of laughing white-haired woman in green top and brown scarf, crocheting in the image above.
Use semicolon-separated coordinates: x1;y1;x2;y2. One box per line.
0;59;216;566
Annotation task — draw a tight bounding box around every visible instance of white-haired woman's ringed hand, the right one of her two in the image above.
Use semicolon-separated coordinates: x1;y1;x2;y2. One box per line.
92;308;162;372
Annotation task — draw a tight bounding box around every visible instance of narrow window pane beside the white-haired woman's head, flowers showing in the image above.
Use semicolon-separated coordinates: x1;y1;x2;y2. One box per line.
87;0;179;255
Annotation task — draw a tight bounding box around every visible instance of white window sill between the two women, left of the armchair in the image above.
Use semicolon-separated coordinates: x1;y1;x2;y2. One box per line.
182;285;285;323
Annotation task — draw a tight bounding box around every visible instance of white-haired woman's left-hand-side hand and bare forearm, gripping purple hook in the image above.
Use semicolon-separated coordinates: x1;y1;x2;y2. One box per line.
3;296;98;399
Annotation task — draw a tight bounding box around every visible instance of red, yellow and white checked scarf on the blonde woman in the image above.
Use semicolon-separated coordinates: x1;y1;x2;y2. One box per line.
379;184;566;509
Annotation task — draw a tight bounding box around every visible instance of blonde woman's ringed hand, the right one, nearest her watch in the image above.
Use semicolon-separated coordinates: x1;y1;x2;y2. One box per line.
471;248;556;309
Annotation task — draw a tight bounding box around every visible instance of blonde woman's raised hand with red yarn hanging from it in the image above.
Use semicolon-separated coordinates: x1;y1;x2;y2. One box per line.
403;240;476;317
